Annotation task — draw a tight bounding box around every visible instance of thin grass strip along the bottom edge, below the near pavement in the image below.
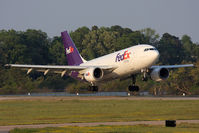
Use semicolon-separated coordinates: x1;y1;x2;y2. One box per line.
10;124;199;133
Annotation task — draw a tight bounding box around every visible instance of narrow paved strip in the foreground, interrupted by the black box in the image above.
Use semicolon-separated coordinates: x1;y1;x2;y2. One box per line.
0;120;199;133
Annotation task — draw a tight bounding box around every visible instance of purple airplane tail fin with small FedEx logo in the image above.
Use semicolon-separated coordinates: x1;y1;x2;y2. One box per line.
61;31;83;66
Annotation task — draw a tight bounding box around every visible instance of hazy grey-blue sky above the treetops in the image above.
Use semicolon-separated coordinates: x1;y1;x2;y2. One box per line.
0;0;199;42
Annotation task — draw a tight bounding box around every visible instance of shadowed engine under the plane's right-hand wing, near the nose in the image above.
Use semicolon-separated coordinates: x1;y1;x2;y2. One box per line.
150;68;169;81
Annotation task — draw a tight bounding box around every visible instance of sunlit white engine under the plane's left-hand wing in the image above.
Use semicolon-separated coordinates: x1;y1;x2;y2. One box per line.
84;68;104;82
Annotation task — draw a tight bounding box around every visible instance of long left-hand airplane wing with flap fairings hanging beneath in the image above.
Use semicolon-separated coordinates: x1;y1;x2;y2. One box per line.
5;64;116;77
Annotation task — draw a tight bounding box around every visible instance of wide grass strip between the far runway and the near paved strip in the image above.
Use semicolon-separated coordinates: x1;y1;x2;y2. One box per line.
0;98;199;125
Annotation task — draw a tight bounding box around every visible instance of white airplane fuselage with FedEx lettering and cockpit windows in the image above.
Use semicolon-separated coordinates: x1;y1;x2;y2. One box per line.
80;44;159;81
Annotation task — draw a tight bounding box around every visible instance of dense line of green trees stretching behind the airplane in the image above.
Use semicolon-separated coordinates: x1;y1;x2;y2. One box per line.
0;25;199;95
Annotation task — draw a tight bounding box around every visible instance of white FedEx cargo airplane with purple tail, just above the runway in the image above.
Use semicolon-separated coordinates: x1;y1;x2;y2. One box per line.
5;31;194;92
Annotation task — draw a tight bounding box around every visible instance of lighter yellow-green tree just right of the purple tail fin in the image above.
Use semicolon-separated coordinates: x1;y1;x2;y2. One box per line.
82;27;118;59
